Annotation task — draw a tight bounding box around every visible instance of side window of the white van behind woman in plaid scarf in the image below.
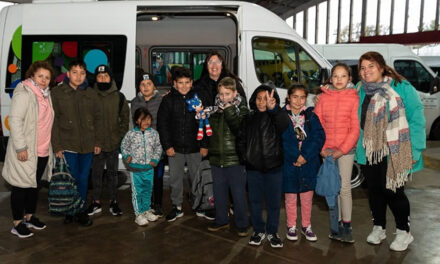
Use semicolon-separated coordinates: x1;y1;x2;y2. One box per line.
394;60;431;93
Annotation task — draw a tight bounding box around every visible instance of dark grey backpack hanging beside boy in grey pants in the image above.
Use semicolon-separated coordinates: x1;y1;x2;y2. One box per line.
192;160;214;210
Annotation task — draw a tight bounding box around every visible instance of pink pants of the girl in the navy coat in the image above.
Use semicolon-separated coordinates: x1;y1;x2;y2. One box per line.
285;191;313;228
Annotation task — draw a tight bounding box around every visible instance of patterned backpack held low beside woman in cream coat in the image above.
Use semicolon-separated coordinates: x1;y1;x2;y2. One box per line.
48;158;84;215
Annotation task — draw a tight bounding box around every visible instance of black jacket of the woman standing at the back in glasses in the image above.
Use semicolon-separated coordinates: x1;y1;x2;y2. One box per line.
194;70;246;106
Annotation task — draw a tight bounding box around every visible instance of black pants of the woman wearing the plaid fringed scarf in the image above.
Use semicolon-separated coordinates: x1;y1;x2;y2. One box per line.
362;158;410;231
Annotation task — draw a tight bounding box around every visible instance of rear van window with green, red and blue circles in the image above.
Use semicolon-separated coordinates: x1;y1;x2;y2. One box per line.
16;35;127;88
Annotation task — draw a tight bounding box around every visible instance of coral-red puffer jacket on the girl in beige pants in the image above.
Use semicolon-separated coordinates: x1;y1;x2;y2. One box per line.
315;87;359;155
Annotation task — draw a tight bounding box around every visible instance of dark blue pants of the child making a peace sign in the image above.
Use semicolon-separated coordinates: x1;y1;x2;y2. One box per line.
247;167;283;234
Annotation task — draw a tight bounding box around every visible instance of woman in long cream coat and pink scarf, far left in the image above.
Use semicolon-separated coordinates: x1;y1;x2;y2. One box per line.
2;61;55;238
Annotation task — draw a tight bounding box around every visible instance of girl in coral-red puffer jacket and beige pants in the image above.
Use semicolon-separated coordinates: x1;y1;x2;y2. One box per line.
315;63;359;243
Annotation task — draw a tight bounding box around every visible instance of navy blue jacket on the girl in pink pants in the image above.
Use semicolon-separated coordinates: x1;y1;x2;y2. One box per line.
281;107;325;193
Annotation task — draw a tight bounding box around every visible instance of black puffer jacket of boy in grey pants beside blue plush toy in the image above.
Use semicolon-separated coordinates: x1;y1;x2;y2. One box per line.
157;88;208;154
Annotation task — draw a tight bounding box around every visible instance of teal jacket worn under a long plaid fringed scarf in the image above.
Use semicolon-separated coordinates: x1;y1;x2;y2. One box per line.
355;80;426;172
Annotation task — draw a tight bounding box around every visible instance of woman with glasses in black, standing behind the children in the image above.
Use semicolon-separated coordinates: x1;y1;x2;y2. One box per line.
194;51;246;106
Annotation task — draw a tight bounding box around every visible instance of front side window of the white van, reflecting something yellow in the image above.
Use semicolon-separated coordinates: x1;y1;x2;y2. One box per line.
252;37;321;91
